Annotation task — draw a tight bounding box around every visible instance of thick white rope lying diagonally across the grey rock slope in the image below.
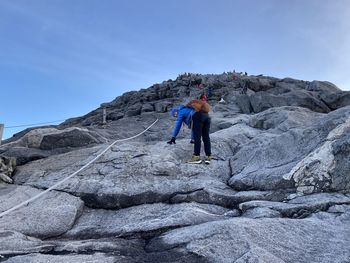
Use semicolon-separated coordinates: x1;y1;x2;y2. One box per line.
0;119;158;217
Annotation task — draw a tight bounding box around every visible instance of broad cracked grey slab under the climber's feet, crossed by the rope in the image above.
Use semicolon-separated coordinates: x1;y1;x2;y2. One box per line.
16;134;238;208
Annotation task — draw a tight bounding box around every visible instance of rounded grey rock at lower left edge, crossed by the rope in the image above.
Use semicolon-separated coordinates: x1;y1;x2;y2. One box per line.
0;185;83;238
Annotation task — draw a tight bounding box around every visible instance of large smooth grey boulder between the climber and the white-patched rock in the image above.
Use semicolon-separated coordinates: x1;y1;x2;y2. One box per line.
229;108;350;191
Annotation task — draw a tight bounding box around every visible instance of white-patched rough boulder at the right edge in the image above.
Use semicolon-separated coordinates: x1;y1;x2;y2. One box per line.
284;116;350;193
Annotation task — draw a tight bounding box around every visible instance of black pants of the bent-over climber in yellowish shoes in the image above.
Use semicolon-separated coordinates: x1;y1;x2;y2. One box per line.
192;112;211;156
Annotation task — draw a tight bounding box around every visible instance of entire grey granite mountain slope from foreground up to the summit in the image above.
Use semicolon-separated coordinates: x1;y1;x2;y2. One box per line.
0;73;350;263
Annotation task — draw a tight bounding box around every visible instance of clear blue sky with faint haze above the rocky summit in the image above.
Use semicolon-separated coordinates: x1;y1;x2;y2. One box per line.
0;0;350;138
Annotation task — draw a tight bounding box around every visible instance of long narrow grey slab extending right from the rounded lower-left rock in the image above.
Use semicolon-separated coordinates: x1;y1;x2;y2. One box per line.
64;203;229;239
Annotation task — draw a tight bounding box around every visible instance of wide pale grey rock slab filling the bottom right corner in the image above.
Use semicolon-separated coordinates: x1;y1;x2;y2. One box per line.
147;218;350;263
